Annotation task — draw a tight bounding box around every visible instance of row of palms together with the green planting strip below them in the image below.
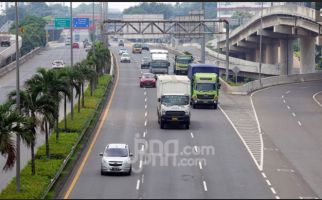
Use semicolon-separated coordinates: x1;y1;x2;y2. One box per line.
0;42;111;199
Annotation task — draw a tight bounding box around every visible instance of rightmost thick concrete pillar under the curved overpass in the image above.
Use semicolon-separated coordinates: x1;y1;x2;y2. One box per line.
300;36;315;74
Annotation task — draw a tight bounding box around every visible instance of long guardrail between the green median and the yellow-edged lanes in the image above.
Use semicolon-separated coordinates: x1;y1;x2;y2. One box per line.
41;53;115;199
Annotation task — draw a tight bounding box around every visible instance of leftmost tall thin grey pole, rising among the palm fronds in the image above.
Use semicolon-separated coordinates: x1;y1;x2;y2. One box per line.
15;2;21;192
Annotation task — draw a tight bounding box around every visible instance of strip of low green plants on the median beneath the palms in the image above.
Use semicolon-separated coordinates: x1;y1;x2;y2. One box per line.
0;75;111;199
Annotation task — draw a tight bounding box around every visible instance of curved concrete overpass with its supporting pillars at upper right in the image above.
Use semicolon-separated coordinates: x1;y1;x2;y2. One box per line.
217;6;322;75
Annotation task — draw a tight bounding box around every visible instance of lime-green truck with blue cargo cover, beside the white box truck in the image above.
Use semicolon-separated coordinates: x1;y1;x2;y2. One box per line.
188;64;221;109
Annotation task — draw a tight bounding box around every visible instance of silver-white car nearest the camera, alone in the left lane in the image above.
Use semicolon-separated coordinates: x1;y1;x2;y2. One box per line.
100;144;133;175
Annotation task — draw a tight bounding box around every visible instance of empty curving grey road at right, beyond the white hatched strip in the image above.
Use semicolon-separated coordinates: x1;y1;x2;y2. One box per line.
253;81;322;198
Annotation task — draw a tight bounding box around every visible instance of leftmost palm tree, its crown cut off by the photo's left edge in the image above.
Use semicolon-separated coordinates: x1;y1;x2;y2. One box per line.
0;102;34;171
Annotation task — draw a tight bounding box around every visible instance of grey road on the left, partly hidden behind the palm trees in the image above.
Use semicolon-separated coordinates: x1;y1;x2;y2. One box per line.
0;43;87;191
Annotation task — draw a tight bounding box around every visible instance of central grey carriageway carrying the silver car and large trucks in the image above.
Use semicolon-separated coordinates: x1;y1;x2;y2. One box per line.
60;44;274;198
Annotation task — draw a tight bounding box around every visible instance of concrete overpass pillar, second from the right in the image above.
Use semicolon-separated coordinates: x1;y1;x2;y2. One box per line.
280;39;293;75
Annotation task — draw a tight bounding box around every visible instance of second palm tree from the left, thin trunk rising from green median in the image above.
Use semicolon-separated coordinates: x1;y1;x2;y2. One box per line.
8;86;56;175
